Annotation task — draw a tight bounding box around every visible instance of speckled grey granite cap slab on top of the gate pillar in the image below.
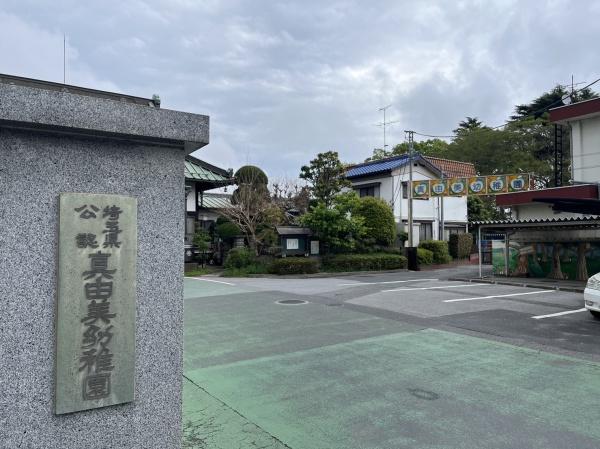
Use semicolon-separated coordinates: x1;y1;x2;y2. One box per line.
0;84;209;153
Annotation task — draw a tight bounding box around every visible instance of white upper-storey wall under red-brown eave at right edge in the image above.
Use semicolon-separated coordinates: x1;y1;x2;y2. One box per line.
569;117;600;183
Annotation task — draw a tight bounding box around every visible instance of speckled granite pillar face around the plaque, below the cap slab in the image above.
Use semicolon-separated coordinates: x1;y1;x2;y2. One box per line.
0;127;184;449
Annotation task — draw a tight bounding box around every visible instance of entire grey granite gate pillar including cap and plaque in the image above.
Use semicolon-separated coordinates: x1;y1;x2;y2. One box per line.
0;75;209;449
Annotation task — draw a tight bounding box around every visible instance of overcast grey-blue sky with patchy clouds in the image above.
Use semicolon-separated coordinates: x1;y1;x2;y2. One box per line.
0;0;600;178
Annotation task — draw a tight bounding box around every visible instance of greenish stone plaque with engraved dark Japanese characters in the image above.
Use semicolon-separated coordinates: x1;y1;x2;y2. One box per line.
55;193;137;414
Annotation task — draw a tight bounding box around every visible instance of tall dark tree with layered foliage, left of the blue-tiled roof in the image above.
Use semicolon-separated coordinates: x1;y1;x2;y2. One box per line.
300;151;351;207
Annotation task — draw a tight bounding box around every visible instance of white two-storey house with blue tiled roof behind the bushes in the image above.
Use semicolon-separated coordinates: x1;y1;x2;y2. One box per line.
346;154;476;245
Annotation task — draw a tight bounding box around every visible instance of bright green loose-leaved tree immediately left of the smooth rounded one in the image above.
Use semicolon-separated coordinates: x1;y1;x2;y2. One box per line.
300;192;366;253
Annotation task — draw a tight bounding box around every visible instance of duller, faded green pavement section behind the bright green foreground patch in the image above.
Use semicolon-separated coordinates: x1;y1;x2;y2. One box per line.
184;292;419;371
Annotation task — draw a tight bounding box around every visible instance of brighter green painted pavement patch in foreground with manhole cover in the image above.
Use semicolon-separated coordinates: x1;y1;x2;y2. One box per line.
187;330;600;449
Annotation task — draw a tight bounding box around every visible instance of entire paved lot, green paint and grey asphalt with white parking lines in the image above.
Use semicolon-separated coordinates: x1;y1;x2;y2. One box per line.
184;271;600;449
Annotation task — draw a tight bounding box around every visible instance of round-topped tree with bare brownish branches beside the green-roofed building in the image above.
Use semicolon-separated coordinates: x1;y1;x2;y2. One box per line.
220;165;272;255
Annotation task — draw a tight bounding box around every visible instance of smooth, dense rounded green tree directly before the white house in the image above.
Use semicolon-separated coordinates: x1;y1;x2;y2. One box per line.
355;196;396;246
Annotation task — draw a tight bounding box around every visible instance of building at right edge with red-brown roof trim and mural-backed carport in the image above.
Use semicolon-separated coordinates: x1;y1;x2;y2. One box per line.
476;98;600;281
